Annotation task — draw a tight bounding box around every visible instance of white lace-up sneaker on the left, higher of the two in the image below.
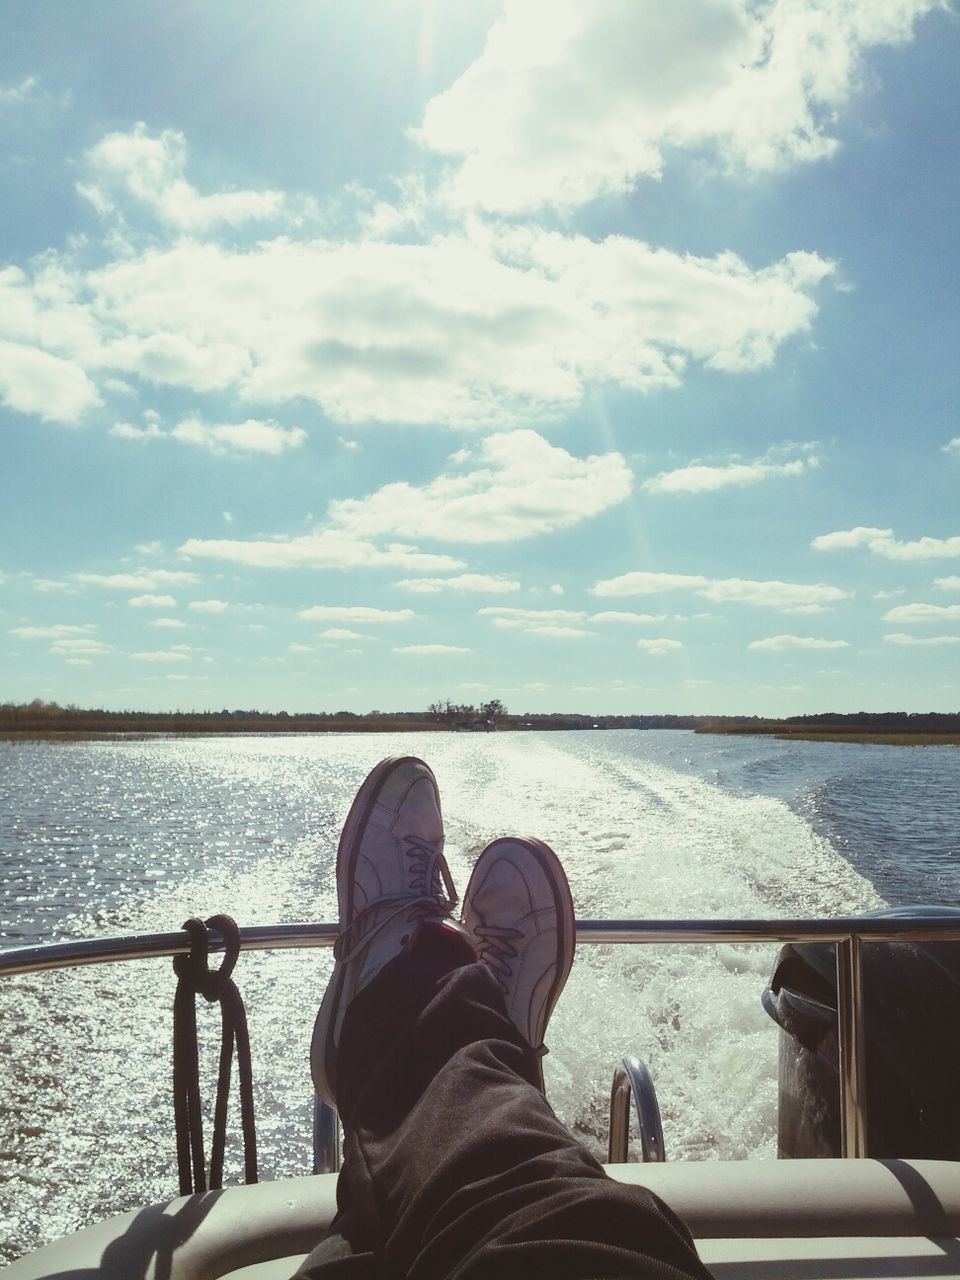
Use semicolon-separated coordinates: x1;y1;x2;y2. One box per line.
310;756;458;1106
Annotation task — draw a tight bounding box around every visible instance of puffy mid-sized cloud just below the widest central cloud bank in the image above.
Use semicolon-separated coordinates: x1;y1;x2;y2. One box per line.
329;430;632;543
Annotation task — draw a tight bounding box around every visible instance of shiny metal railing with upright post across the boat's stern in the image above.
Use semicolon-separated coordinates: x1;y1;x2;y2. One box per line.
0;909;960;1157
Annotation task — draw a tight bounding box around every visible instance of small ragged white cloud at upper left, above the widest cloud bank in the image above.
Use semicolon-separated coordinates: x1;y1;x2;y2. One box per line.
77;123;284;234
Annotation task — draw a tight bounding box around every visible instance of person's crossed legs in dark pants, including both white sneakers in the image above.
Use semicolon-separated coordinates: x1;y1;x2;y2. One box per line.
300;760;705;1280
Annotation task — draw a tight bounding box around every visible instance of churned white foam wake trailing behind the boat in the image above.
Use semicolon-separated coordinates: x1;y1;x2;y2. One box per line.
427;735;881;1158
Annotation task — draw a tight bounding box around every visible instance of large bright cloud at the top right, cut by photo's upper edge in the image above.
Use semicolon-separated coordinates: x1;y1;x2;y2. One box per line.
415;0;942;212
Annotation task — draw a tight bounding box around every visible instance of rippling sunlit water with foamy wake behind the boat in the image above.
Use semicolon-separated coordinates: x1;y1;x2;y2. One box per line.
0;731;960;1258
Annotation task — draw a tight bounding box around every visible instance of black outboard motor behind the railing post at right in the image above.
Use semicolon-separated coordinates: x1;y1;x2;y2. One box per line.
763;906;960;1160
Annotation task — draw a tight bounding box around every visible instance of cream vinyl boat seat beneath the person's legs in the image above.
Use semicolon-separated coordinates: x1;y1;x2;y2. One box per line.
6;1160;960;1280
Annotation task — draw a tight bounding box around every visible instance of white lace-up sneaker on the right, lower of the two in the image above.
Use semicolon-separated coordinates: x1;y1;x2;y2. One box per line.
461;837;576;1089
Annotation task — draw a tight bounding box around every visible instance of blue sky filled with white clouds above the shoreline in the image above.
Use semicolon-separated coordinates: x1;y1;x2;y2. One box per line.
0;0;960;716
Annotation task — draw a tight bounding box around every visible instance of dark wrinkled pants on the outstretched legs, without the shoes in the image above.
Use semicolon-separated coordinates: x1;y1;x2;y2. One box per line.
296;931;707;1280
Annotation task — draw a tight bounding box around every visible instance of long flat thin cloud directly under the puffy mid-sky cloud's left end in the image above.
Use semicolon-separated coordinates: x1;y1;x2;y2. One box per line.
179;529;465;572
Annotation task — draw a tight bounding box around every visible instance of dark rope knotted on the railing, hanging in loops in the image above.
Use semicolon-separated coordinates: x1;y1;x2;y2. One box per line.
173;915;257;1196
